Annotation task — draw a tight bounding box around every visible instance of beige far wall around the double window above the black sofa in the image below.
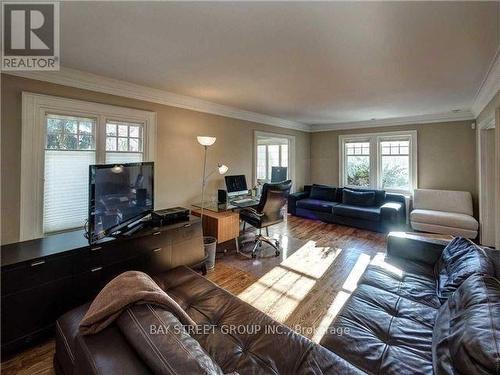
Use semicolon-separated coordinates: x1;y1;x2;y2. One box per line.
311;121;477;212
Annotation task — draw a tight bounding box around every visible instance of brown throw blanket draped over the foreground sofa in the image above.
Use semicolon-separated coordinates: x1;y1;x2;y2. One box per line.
80;271;196;335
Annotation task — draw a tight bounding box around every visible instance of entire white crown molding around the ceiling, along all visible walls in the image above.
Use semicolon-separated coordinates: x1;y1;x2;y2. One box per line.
2;67;480;132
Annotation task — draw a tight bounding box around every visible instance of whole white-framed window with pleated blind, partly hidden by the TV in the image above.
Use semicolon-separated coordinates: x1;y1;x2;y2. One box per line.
20;93;156;240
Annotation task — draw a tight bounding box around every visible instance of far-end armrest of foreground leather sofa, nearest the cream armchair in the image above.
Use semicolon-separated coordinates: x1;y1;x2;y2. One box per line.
387;232;451;265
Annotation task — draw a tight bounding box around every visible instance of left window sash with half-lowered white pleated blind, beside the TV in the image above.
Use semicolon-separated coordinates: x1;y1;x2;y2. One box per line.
43;115;96;234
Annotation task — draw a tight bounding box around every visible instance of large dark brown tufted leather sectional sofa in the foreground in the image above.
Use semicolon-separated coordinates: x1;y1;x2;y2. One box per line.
54;234;500;375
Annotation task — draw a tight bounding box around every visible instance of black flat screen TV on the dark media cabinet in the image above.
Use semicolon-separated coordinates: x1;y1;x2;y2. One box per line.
88;162;154;243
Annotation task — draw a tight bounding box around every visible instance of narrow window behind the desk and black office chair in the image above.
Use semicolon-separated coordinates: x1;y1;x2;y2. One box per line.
255;132;294;183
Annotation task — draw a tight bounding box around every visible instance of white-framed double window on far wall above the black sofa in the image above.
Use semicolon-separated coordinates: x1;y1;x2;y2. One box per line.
339;131;417;193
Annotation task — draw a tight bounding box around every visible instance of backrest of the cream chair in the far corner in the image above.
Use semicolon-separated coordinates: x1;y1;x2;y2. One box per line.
413;189;473;216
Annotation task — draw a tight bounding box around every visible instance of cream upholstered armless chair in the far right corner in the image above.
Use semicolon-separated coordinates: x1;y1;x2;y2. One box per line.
410;189;479;238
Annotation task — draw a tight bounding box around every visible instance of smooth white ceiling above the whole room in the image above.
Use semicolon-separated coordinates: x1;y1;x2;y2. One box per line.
61;2;500;124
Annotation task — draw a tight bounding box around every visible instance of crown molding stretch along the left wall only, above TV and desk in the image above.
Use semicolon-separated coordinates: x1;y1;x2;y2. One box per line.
2;67;311;132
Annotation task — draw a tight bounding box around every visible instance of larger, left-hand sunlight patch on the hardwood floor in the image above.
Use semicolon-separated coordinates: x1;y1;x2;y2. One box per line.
238;241;342;322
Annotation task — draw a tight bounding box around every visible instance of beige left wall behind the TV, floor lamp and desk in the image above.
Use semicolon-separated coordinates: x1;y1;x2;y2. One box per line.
1;74;310;243
